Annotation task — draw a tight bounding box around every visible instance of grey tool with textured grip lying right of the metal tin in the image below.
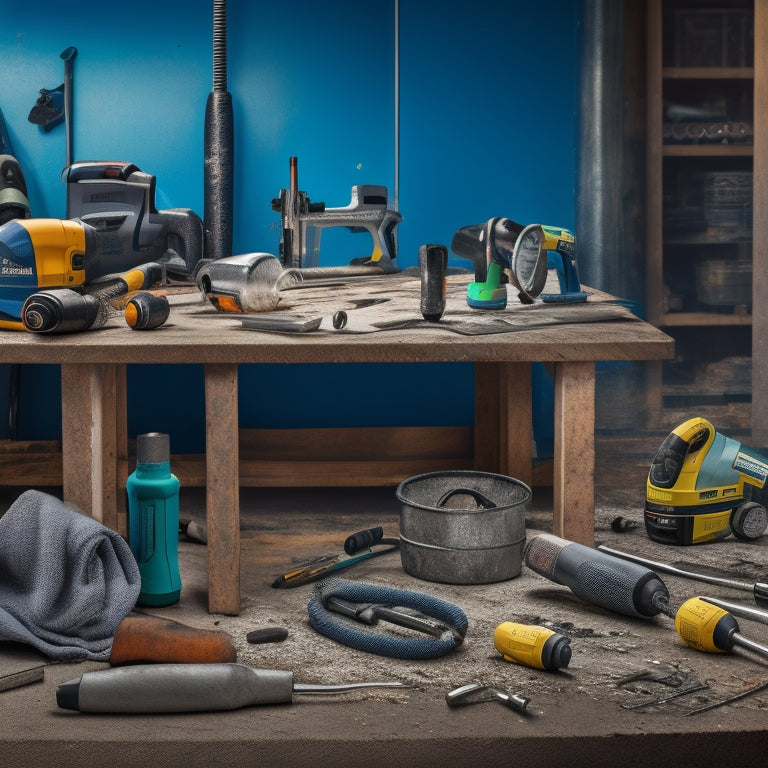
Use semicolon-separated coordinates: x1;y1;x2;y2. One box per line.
525;533;669;617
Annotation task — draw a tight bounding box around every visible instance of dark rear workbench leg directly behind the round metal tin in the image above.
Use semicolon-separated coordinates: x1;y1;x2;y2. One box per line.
474;363;533;485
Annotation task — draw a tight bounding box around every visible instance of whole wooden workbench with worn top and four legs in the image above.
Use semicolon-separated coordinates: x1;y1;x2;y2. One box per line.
0;275;673;615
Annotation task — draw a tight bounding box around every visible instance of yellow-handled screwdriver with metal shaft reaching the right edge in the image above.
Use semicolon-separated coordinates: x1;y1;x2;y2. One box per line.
675;597;768;658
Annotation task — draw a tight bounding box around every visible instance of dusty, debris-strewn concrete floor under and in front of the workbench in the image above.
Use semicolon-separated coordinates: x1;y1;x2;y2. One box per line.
0;470;768;768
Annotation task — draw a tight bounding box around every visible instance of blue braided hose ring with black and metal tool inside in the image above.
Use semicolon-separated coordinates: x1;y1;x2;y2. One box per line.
307;579;468;659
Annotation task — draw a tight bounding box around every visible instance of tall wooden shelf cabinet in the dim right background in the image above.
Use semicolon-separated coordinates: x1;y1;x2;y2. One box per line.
646;0;768;430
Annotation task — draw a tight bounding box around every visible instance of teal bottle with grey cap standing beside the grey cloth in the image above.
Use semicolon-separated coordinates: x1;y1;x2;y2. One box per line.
126;432;181;606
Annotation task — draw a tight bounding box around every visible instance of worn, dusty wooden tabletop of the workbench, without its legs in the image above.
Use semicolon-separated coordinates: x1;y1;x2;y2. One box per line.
0;273;673;363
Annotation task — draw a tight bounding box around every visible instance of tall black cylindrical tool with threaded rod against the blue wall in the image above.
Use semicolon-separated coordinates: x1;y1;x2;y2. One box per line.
203;0;235;259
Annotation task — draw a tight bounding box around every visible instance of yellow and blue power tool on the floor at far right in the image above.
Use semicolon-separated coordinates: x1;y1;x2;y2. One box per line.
645;417;768;544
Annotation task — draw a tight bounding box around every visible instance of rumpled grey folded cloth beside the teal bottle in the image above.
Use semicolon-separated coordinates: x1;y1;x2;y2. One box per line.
0;490;141;661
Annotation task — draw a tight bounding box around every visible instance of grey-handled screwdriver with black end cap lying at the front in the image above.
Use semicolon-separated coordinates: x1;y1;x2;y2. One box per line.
56;663;409;714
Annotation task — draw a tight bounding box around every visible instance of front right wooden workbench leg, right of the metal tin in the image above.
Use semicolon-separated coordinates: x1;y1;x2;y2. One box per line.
553;362;595;547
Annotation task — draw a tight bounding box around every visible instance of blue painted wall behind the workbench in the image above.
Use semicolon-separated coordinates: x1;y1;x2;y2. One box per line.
0;0;579;452
